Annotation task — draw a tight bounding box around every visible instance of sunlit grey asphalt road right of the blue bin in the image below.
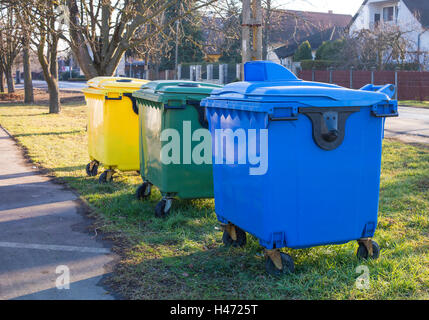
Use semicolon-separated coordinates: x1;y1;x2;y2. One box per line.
384;107;429;144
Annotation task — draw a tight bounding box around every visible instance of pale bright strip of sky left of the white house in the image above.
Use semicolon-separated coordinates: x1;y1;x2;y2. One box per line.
276;0;363;15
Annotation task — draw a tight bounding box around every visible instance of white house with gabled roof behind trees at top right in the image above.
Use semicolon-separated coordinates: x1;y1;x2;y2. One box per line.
349;0;429;66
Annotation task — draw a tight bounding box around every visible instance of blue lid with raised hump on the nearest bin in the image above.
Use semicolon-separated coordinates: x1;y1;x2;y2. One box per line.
201;61;395;112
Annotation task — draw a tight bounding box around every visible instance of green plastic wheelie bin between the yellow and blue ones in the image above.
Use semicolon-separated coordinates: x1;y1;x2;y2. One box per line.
133;81;221;217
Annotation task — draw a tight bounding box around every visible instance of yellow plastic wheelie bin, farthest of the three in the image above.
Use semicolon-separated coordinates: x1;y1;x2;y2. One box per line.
82;77;149;183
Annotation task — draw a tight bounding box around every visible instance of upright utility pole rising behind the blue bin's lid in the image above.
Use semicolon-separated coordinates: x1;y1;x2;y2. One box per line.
241;0;262;77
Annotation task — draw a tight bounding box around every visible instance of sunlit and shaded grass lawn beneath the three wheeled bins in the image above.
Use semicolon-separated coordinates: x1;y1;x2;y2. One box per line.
0;106;429;299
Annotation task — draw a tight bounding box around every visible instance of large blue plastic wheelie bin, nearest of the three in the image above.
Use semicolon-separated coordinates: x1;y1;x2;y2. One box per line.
201;61;398;274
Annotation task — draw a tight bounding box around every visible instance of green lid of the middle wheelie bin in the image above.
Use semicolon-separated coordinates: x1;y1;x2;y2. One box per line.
133;80;222;102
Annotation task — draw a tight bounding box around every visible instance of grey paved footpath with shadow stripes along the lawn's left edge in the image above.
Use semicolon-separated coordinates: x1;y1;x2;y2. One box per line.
0;127;116;300
